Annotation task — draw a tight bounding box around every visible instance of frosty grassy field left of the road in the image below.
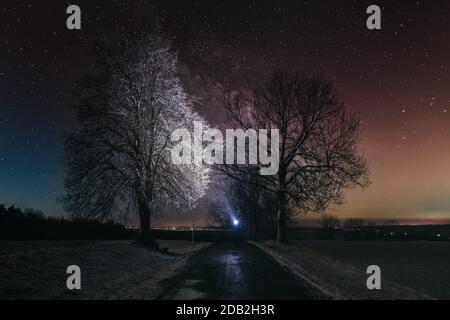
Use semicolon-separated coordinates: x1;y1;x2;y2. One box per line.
0;240;207;299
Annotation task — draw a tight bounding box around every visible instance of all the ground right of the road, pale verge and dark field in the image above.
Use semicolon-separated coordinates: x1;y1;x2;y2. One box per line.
255;240;450;299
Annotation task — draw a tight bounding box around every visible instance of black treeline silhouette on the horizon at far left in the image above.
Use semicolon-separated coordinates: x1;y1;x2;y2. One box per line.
0;204;135;240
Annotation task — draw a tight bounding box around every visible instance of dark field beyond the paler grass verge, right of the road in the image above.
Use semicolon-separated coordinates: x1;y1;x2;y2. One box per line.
294;241;450;299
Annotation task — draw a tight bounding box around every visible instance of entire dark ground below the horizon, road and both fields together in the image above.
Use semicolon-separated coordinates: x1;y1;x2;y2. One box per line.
0;240;450;299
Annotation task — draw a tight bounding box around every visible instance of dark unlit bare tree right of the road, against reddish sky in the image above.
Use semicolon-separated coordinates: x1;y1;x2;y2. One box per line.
218;72;369;242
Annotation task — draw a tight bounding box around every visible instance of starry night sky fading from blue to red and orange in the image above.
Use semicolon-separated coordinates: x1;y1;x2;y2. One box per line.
0;0;450;225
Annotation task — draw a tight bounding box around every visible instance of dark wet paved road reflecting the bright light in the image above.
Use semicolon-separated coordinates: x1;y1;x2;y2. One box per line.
161;242;311;300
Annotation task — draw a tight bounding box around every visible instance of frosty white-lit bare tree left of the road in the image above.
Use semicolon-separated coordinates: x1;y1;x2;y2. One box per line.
62;34;209;243
